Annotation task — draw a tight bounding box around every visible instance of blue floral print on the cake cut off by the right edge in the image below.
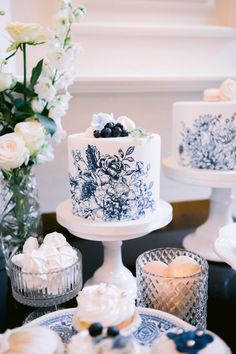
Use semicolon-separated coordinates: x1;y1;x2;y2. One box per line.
179;113;236;170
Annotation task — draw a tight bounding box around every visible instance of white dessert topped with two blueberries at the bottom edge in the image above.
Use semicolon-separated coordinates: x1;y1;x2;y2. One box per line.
67;322;143;354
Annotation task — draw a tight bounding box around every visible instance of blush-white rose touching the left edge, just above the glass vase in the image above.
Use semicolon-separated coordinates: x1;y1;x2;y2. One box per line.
0;133;29;170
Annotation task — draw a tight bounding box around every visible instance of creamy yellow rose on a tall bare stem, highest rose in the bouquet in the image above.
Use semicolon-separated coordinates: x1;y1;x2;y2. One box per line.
6;22;46;49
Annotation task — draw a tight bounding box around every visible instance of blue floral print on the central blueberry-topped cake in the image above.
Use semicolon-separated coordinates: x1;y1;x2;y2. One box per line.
69;145;154;221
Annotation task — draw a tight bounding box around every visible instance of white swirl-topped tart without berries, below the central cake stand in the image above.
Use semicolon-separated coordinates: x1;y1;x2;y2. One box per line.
73;283;139;330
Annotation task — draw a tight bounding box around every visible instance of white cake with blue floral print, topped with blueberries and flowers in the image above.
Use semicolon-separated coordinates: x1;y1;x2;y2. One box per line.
68;114;161;222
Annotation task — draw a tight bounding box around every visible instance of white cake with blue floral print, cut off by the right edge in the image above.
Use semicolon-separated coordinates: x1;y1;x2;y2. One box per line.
172;80;236;171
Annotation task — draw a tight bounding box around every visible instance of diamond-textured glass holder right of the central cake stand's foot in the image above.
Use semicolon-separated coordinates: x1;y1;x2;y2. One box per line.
136;248;208;328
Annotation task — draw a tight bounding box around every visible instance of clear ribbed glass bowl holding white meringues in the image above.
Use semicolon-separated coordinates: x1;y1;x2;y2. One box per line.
9;249;82;307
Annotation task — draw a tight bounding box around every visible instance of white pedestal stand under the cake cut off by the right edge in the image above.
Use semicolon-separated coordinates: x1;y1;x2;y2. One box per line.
162;156;236;262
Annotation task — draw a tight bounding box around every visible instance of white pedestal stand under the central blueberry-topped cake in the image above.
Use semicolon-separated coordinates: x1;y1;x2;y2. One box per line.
56;200;172;295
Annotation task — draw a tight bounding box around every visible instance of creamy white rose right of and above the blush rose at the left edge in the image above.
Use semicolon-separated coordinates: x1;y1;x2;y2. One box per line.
15;121;45;154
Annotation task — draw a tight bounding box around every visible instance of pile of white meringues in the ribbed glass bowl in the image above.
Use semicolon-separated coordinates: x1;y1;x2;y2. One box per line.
11;232;78;294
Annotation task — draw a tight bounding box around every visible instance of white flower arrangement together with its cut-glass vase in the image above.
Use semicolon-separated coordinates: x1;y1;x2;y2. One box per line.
0;0;85;268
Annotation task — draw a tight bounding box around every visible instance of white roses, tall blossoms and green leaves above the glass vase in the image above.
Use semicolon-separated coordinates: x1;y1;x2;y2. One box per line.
0;0;85;173
